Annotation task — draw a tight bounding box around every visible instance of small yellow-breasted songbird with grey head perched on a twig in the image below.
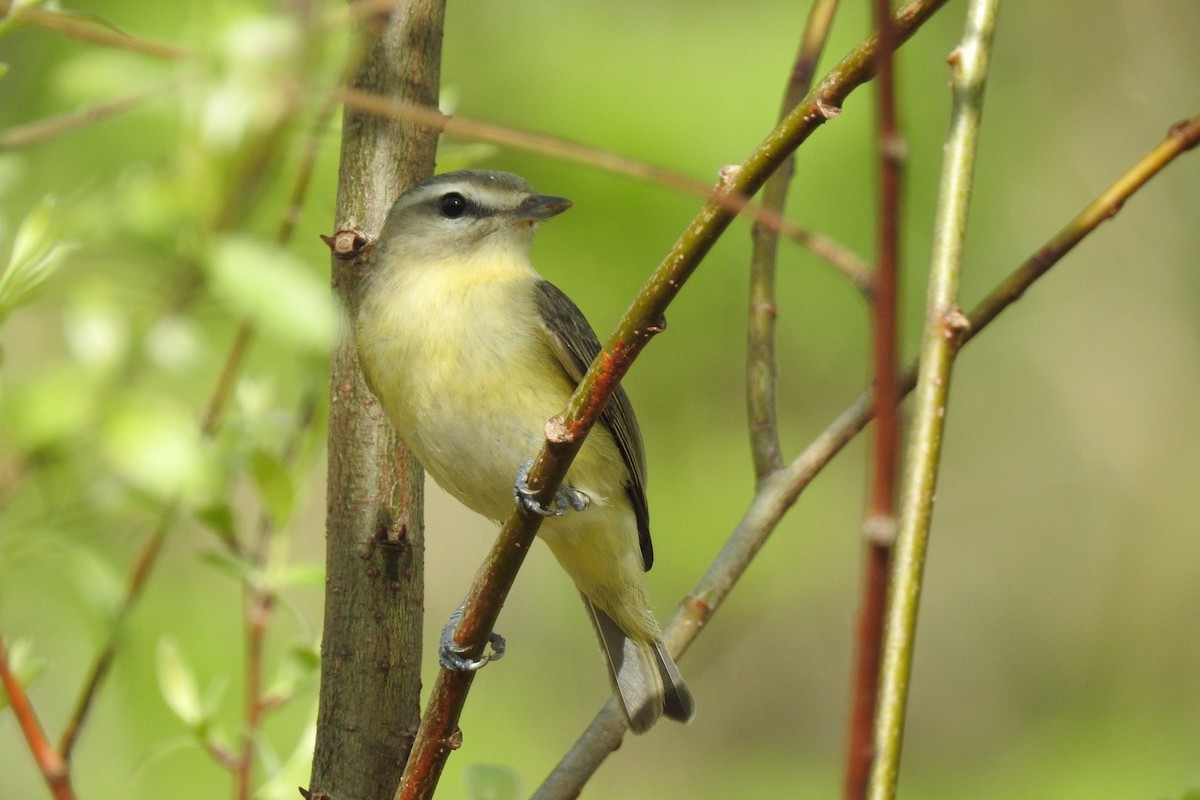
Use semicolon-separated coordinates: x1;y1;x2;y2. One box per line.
355;170;694;733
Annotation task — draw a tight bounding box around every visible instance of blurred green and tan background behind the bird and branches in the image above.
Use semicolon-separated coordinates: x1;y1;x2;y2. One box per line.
0;0;1200;800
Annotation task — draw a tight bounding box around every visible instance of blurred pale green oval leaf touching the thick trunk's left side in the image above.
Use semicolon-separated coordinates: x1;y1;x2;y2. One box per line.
209;236;336;354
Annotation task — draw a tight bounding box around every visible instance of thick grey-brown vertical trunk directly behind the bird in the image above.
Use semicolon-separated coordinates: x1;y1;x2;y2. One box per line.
308;0;444;798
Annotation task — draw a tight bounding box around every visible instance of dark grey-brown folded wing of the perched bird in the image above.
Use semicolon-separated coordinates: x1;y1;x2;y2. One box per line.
538;281;654;570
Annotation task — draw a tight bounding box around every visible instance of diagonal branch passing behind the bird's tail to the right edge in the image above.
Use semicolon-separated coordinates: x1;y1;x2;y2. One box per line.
534;106;1200;800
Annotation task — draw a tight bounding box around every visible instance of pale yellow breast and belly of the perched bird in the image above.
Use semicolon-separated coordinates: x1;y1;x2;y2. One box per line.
359;262;656;639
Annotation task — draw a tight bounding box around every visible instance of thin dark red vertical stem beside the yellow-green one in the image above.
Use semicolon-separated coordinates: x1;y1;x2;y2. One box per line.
842;0;904;800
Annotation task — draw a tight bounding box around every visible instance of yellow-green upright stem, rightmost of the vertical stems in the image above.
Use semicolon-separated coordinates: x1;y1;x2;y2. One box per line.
869;0;1000;800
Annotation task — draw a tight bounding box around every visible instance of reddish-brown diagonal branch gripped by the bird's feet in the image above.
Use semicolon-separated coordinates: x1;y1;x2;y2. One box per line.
395;0;944;800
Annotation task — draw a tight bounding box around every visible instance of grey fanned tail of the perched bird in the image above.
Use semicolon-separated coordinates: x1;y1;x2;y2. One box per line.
583;596;696;733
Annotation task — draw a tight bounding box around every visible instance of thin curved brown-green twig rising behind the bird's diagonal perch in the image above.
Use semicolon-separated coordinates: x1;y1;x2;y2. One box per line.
746;0;838;480
